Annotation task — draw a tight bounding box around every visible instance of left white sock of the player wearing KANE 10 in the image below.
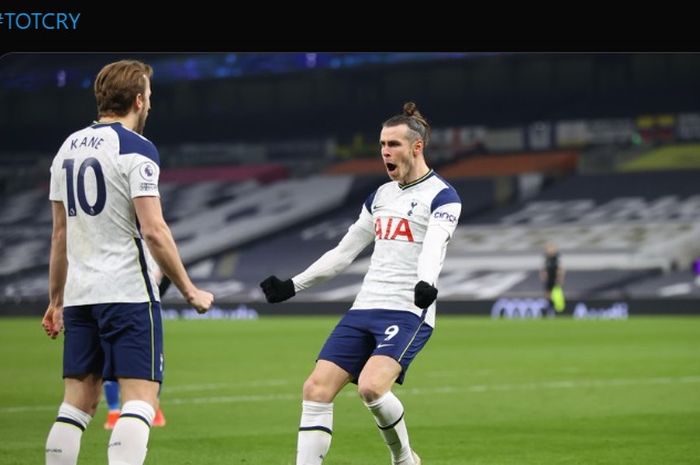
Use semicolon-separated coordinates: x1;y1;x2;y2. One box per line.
46;402;92;465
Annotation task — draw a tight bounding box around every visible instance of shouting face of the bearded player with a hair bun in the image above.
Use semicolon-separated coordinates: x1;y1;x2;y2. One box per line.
379;124;423;184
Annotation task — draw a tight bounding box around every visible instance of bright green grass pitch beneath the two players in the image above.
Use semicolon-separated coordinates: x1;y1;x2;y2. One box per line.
0;314;700;465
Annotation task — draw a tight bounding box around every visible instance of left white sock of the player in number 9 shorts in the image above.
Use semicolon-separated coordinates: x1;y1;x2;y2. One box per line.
297;400;333;465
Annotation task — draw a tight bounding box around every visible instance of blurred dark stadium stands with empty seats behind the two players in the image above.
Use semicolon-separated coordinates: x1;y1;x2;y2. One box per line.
0;53;700;318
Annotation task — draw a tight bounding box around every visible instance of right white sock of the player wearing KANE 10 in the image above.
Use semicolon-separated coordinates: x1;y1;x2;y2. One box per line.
107;400;156;465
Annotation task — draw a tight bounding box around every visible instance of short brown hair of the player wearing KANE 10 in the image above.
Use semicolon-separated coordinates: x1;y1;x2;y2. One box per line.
95;60;153;117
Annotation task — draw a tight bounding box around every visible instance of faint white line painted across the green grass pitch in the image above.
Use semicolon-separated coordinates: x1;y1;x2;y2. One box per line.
0;376;700;413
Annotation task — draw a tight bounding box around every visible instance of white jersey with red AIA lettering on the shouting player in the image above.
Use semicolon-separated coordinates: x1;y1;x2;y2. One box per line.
352;170;462;326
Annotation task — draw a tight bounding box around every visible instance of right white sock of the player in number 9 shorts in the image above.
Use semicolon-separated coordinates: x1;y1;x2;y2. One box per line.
365;391;413;464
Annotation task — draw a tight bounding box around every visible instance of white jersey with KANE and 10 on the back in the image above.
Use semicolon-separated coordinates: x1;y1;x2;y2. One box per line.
49;123;160;306
